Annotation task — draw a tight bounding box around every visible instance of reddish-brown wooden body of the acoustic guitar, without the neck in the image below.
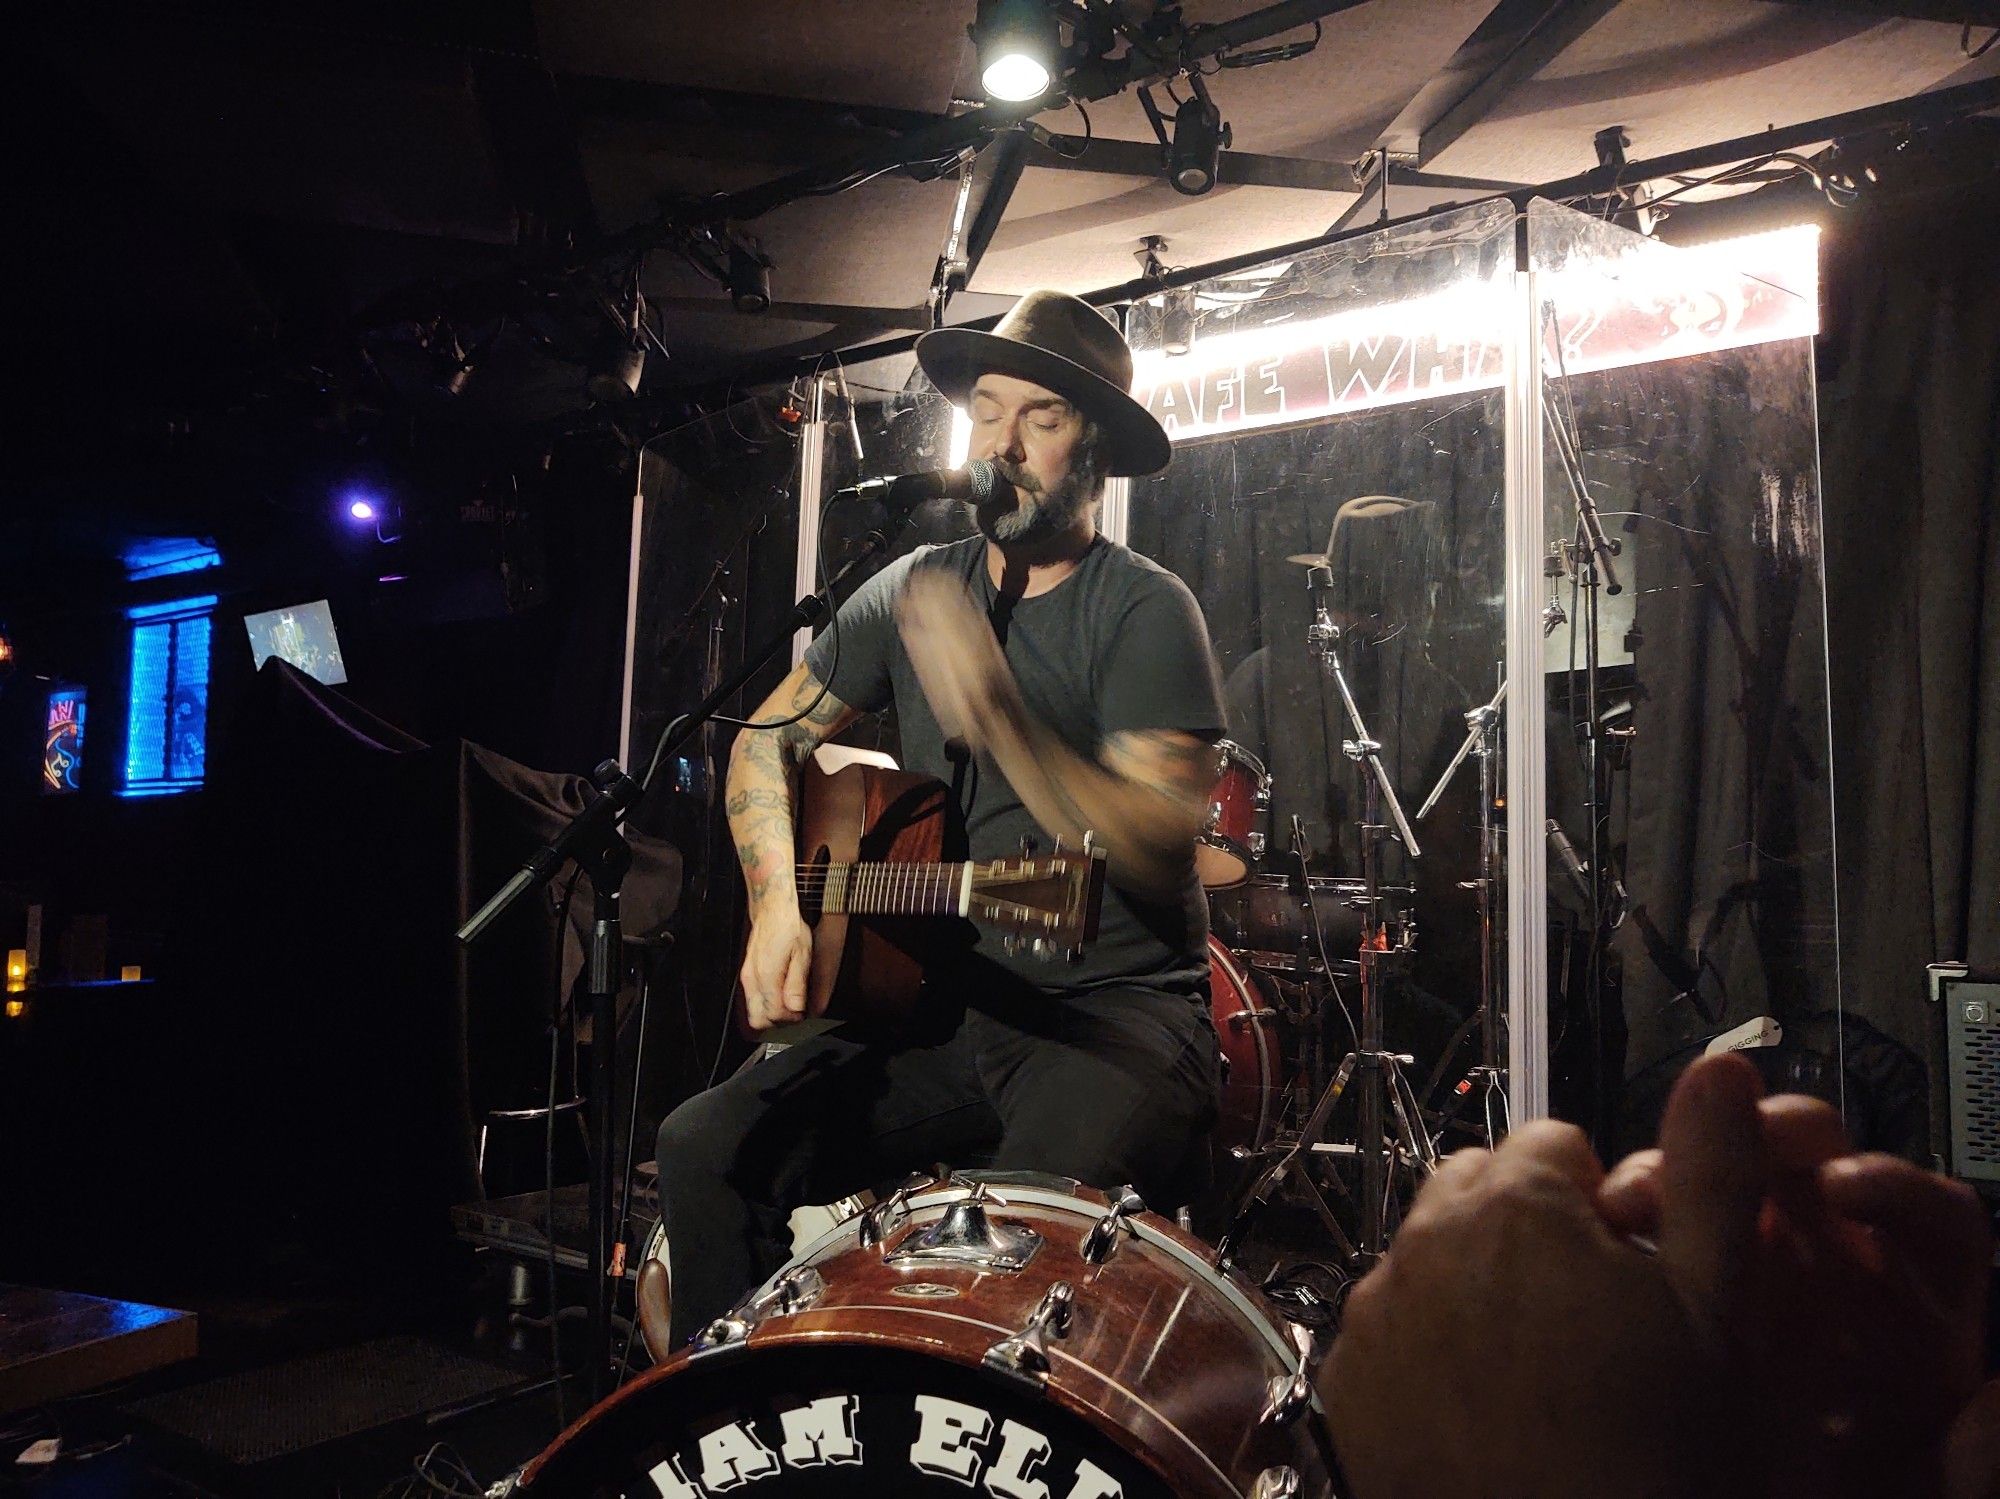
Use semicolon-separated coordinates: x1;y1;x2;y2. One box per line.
798;761;964;1027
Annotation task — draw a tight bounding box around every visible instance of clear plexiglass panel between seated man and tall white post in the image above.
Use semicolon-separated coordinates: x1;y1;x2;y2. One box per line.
1128;202;1516;1199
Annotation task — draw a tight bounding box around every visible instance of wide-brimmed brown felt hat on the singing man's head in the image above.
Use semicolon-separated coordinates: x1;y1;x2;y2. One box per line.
916;290;1174;476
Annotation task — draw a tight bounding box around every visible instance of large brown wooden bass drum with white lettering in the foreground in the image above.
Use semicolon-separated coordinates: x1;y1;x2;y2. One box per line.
516;1173;1332;1499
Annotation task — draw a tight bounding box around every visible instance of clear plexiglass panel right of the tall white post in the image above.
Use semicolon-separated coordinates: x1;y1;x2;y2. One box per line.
1528;202;1842;1147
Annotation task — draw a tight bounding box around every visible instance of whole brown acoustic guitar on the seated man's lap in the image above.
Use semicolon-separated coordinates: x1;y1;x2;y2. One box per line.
764;761;1104;1041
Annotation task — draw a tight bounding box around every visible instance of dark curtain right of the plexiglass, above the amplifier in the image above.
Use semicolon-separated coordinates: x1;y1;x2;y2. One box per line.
1820;140;2000;1151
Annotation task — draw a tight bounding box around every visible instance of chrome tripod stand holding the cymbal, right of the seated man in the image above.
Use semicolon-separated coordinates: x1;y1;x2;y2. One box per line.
1216;564;1436;1267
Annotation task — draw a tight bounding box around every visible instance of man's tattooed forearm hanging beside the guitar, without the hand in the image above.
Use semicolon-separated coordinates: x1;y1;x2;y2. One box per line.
724;662;860;919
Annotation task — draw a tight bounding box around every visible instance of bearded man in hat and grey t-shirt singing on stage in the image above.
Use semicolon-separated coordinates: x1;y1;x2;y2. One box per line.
660;292;1224;1345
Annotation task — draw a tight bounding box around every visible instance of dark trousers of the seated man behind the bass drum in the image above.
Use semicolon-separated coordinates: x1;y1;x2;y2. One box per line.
660;989;1218;1347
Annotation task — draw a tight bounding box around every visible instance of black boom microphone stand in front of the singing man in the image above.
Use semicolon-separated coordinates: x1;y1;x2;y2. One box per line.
458;511;888;1403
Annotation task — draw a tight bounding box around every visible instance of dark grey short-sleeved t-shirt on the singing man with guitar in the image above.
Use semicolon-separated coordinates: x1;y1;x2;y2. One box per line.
806;536;1222;995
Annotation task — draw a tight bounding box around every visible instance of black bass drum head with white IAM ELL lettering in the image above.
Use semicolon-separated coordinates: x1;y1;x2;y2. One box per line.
518;1343;1172;1499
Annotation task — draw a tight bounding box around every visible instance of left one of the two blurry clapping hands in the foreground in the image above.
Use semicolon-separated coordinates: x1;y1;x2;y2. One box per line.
1320;1075;1758;1499
